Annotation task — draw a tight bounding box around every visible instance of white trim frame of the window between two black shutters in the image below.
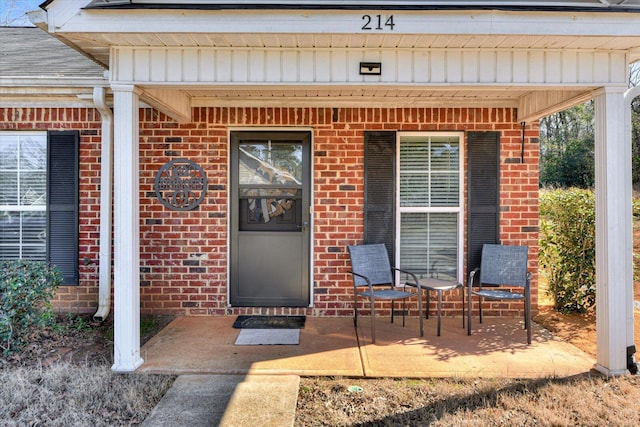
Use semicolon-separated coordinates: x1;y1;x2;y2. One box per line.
394;131;466;283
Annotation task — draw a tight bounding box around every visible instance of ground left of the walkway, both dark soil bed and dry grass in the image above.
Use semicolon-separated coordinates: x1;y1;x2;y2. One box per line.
0;315;174;427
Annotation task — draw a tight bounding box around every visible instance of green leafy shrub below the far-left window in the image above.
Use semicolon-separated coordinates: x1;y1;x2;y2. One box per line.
0;260;62;355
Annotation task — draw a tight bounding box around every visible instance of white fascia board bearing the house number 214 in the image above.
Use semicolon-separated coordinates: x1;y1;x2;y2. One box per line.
49;9;640;37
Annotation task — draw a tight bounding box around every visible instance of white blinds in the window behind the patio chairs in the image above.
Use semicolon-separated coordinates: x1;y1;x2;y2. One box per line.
396;134;462;280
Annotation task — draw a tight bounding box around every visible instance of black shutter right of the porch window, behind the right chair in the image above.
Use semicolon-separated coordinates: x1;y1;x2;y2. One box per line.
467;132;500;271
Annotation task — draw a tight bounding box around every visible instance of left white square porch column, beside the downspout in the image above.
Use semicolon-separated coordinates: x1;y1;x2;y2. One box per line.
111;85;143;372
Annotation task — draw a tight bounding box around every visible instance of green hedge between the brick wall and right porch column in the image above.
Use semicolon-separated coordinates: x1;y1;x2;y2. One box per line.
539;188;596;313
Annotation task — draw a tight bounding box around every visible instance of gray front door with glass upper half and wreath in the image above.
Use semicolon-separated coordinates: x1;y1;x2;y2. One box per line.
229;132;311;307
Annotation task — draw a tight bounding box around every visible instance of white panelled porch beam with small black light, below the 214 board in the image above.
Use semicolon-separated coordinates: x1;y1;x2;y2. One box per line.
110;46;628;88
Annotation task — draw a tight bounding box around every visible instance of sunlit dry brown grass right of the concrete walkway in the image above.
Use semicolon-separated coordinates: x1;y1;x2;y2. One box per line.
295;374;640;426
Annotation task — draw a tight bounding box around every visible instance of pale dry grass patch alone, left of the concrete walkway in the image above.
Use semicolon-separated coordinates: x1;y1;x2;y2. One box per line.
0;362;173;427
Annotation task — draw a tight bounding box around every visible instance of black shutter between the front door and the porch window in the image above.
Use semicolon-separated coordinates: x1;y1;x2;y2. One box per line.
364;132;396;265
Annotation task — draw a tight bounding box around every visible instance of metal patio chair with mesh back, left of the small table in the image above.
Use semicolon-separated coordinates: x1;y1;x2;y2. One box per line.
348;243;424;344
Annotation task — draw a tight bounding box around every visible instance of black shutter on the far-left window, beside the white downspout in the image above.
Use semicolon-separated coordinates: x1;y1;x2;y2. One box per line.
47;131;80;285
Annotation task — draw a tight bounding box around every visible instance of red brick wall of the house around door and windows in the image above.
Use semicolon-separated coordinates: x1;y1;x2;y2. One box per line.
0;108;539;316
